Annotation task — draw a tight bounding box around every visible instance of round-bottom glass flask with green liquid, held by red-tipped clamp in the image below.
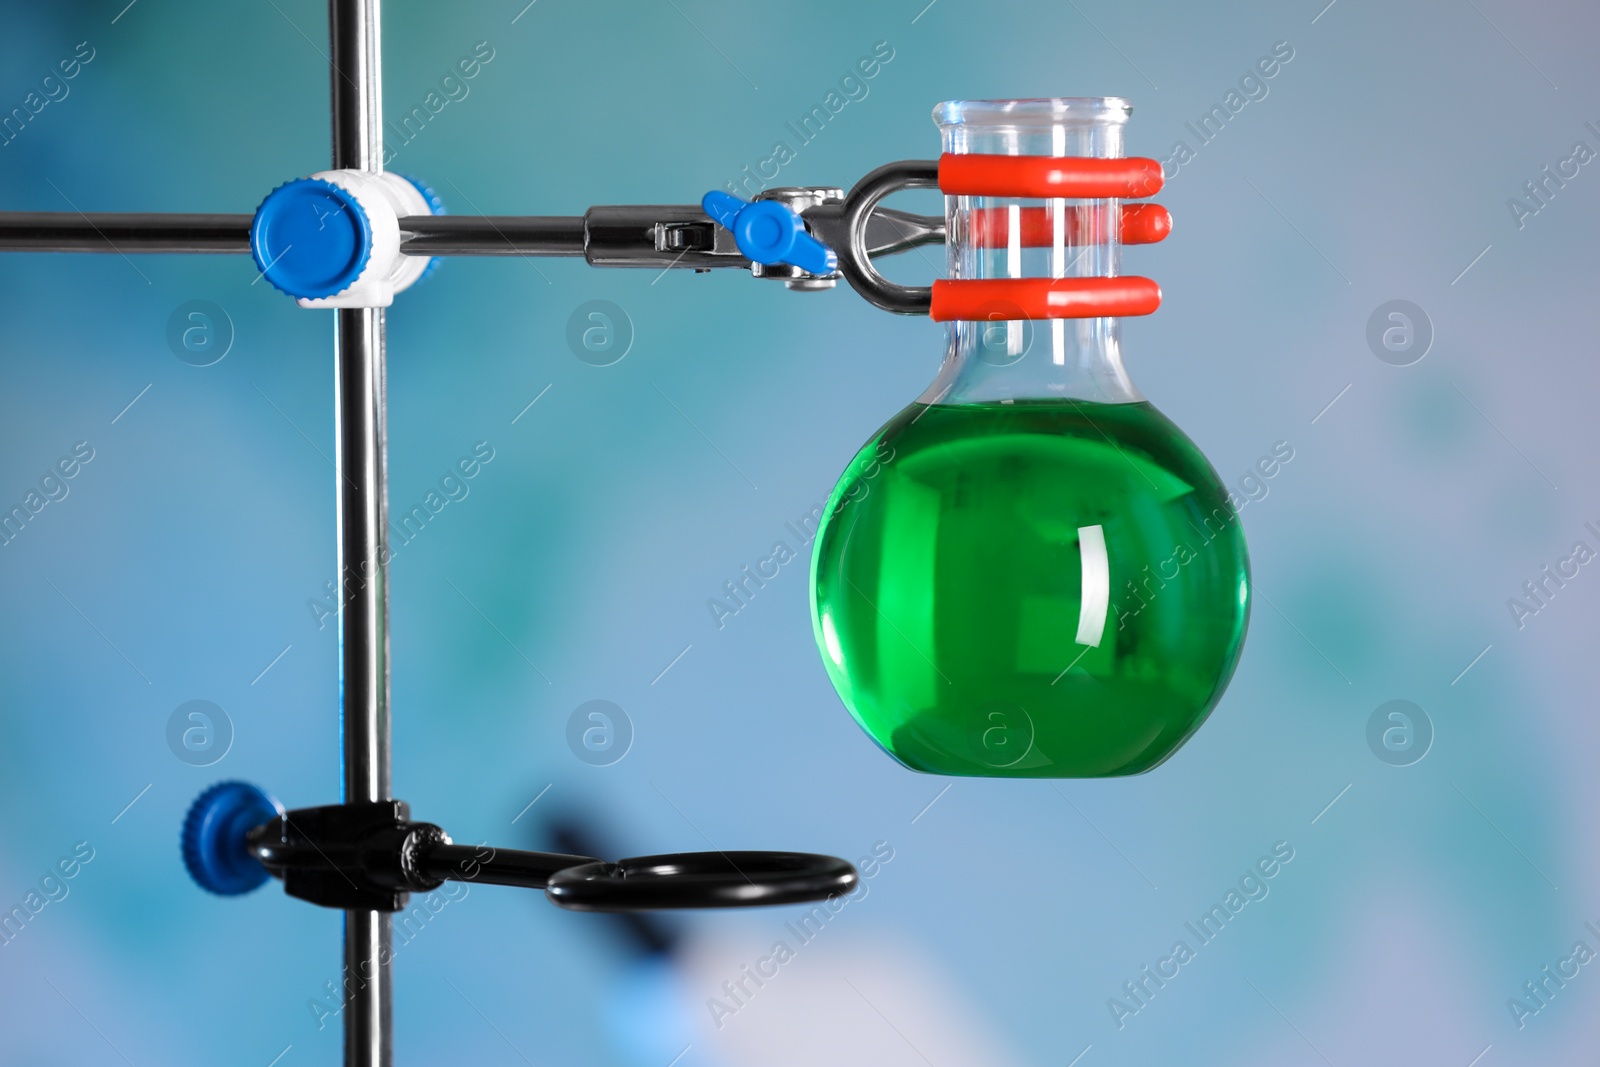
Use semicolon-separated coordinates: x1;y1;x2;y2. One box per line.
811;98;1250;777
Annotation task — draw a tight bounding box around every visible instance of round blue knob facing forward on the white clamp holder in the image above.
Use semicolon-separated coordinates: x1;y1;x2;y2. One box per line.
250;178;373;299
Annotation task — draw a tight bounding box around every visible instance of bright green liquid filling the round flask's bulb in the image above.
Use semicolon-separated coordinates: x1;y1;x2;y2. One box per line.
811;400;1250;777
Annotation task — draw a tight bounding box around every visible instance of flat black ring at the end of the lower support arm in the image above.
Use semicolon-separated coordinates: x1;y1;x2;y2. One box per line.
544;853;861;912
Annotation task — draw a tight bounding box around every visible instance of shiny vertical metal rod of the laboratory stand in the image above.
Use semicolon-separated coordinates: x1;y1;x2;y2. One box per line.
328;0;394;1067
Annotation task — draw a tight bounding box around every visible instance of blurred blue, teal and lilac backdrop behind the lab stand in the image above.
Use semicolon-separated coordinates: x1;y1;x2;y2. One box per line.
0;0;1600;1067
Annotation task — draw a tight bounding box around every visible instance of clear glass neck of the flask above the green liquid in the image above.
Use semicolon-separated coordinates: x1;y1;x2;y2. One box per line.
918;98;1144;405
